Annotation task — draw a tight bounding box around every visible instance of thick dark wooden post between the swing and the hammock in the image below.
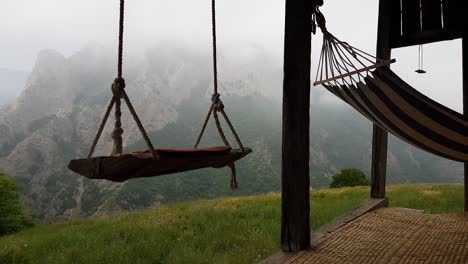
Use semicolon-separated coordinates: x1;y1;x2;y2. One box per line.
281;0;315;252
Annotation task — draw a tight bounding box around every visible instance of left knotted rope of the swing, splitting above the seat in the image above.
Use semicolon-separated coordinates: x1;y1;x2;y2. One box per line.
88;0;159;159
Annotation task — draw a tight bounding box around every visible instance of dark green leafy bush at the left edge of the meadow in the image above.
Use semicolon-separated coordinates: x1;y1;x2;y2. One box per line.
0;173;34;236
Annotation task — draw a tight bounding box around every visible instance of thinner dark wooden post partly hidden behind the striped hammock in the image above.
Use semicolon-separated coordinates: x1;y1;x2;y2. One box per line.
371;0;392;198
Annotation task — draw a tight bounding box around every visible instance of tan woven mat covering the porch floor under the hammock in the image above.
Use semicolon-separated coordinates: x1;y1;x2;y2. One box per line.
287;208;468;264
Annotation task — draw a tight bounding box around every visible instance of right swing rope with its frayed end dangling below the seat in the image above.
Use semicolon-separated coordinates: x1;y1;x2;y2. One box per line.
194;0;245;190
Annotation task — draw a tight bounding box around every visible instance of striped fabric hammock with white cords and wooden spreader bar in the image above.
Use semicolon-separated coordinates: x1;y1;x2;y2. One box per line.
314;32;468;162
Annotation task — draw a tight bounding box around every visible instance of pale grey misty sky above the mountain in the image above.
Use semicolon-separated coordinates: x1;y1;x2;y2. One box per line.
0;0;462;111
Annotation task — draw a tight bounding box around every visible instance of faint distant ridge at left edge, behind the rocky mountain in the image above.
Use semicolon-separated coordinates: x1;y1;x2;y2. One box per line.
0;68;29;107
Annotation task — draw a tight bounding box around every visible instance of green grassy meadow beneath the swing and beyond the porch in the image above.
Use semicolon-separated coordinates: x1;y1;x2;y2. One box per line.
0;185;463;264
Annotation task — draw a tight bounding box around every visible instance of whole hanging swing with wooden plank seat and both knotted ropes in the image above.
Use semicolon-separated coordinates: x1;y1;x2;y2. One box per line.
68;0;252;189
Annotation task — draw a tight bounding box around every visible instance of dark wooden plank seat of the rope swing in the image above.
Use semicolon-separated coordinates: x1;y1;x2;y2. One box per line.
68;147;252;182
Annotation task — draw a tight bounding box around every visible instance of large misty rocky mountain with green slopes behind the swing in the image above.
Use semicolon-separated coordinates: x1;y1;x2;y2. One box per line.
0;45;462;221
